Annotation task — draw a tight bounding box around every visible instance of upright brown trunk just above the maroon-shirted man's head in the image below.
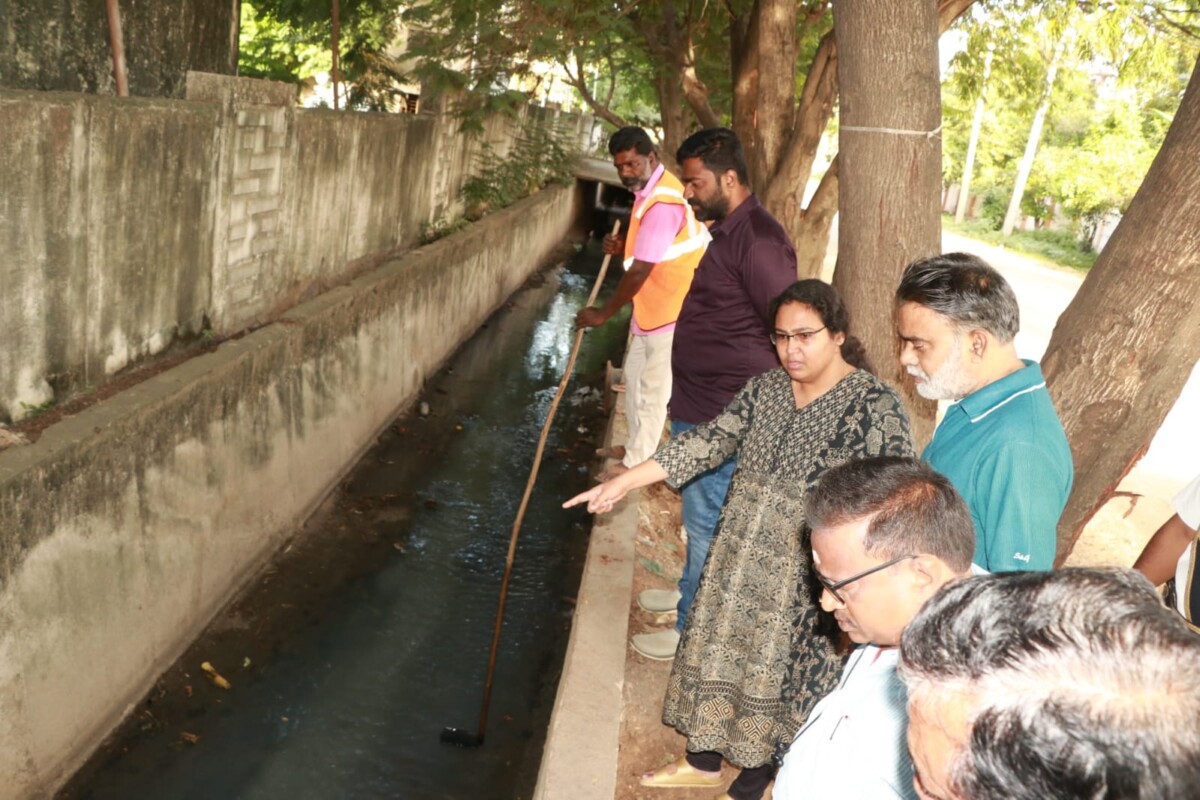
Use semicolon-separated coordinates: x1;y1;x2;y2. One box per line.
749;0;796;186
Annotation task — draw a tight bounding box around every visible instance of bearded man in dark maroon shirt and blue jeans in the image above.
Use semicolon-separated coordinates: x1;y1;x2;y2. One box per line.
634;128;796;658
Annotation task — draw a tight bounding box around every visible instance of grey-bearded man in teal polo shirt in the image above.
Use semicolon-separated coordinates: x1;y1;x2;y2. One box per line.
895;253;1074;572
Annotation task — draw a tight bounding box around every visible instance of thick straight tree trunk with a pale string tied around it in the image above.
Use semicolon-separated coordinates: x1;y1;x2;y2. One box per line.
834;0;942;444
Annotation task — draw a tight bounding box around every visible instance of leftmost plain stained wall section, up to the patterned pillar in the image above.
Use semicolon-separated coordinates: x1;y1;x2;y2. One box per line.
0;91;217;420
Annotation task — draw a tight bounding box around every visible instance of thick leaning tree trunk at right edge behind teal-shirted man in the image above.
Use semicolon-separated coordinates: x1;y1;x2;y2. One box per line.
1043;57;1200;564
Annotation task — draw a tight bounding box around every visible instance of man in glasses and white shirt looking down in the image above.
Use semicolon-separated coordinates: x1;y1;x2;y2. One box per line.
772;457;974;800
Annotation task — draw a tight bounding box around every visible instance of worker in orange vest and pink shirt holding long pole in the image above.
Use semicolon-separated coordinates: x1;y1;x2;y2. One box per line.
575;126;709;484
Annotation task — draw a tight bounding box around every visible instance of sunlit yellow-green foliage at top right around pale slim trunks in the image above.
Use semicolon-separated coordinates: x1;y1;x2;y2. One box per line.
942;0;1200;233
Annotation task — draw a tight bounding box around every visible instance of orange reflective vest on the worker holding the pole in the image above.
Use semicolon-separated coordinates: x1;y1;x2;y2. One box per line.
625;170;712;331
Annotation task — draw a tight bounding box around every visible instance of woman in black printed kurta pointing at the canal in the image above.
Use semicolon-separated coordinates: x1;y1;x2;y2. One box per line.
571;281;913;800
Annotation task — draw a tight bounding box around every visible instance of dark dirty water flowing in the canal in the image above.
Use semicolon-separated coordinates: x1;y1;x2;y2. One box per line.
59;242;626;800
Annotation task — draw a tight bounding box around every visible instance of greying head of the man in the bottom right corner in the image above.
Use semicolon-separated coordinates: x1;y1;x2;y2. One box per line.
900;569;1200;800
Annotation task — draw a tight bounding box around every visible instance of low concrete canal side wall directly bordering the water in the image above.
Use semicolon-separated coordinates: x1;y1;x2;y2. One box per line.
0;187;581;800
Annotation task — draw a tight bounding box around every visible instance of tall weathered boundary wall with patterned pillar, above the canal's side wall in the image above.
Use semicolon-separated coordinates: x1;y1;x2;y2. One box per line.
0;72;595;422
